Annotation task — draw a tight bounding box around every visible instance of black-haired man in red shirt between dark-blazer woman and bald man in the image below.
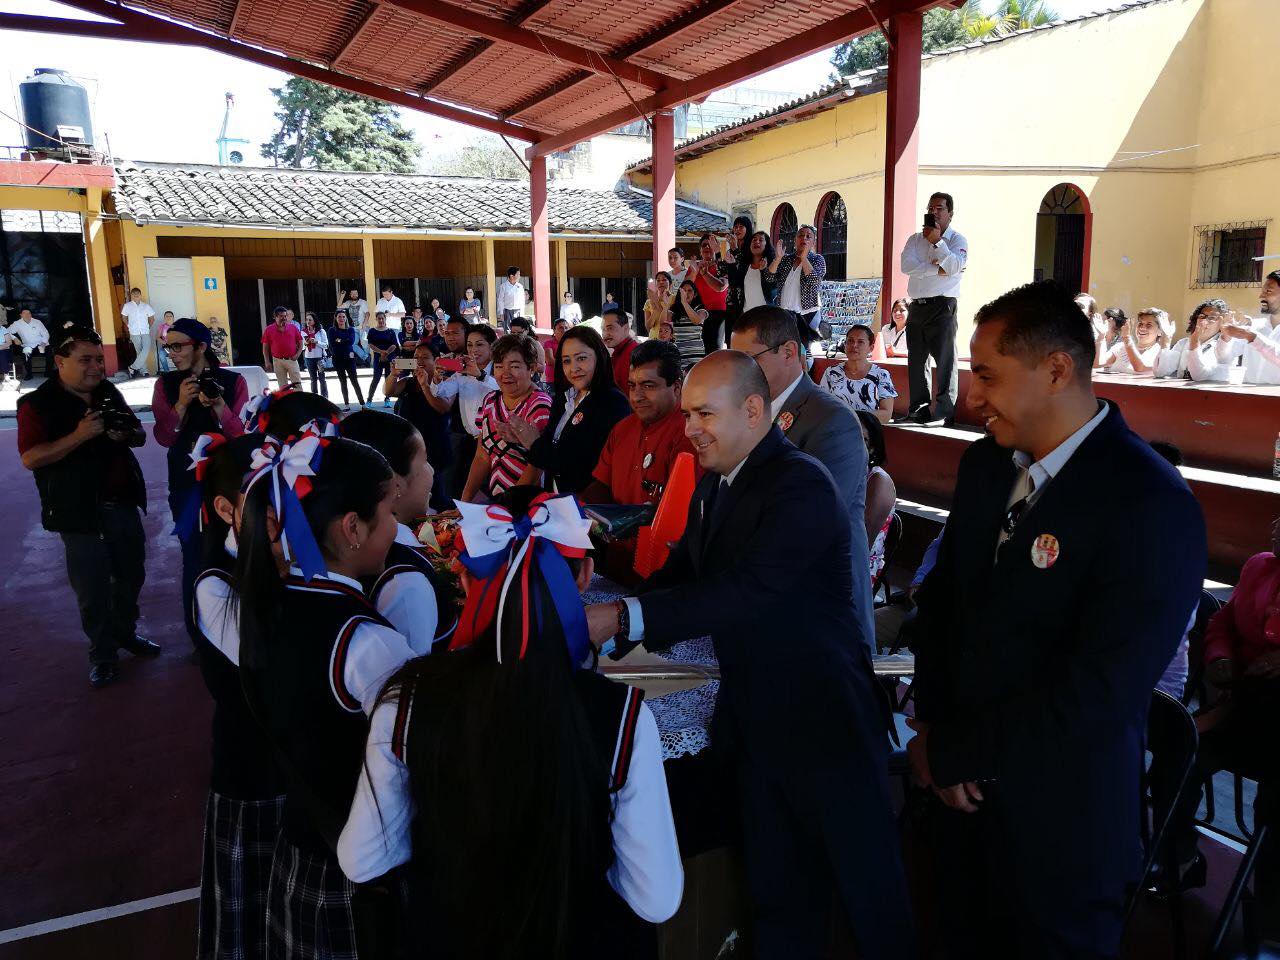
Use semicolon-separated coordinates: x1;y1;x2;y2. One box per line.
581;340;701;503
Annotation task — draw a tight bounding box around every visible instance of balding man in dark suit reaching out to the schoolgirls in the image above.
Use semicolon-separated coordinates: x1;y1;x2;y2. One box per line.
588;351;911;960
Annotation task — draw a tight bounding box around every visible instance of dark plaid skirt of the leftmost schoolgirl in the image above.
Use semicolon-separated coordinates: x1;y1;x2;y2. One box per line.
196;791;284;960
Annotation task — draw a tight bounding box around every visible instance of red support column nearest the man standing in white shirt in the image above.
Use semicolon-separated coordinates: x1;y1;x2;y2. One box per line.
877;13;924;349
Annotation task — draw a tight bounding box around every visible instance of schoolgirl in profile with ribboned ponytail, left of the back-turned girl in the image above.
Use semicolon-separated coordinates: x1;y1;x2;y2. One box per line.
234;435;412;960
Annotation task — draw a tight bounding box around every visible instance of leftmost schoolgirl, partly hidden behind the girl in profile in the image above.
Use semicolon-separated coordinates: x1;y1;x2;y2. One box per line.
186;434;284;960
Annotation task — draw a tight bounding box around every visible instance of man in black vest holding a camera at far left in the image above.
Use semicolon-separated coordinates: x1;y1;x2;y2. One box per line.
18;326;160;687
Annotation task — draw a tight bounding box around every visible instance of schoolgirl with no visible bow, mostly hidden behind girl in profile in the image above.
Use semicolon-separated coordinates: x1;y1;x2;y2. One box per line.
338;410;458;657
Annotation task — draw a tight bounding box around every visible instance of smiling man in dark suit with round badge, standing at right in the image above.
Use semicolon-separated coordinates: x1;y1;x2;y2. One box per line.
908;282;1206;960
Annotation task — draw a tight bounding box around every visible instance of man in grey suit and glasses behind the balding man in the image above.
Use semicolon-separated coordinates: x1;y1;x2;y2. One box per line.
732;307;876;653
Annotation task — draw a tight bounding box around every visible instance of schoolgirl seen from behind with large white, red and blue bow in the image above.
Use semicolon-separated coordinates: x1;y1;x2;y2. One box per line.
338;486;684;960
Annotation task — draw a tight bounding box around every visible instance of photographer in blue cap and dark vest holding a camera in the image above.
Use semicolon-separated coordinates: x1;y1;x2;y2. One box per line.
151;316;248;647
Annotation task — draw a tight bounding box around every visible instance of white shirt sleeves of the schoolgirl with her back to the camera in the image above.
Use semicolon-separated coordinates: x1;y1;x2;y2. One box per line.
337;700;685;923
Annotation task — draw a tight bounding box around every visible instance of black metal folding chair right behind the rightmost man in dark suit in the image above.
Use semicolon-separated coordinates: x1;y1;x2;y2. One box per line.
1124;690;1199;957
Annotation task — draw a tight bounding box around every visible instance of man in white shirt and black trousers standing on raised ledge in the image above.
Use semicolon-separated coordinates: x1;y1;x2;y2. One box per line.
901;193;969;424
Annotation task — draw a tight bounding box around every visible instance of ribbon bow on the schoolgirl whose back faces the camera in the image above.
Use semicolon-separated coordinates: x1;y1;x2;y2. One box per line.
449;494;591;666
